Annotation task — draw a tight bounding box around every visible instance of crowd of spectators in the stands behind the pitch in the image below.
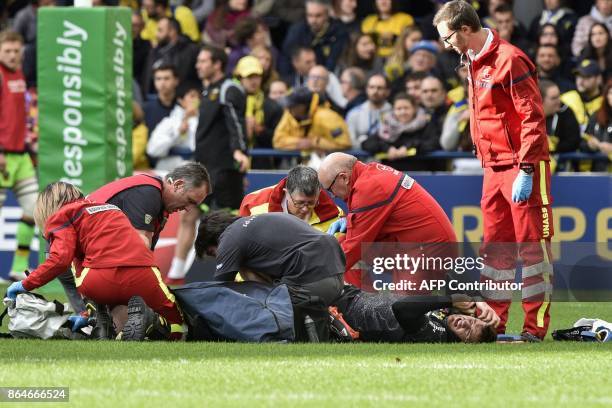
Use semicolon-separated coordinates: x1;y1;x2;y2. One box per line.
0;0;612;171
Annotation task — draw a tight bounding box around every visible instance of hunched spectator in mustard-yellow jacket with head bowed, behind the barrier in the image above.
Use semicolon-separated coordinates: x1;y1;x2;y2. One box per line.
272;88;351;151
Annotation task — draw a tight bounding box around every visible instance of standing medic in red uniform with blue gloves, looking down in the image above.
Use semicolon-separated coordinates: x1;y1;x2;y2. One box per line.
434;0;553;341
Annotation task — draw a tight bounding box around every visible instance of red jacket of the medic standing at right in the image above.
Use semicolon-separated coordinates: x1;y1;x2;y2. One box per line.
468;30;550;167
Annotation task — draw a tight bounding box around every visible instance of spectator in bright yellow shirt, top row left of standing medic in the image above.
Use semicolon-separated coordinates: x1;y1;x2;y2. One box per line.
361;0;414;58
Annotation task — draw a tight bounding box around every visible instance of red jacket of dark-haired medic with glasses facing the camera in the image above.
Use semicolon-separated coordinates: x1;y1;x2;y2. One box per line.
239;177;344;232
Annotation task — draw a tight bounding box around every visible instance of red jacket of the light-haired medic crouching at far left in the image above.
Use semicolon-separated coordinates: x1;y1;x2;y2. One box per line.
22;199;155;290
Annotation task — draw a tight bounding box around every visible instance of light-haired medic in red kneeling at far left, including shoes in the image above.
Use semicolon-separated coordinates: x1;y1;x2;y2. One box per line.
7;182;183;340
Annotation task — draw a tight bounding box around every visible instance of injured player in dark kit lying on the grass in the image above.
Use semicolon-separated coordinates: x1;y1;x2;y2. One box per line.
336;285;499;343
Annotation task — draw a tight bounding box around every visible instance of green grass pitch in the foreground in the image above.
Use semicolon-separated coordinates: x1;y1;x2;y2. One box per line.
0;280;612;407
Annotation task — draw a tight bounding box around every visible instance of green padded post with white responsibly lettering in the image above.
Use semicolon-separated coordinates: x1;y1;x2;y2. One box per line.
37;7;132;194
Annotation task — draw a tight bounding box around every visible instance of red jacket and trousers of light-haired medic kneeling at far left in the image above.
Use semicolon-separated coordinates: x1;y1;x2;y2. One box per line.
21;199;183;338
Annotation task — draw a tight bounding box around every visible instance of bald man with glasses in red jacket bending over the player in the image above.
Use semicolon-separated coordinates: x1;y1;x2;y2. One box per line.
319;153;457;287
